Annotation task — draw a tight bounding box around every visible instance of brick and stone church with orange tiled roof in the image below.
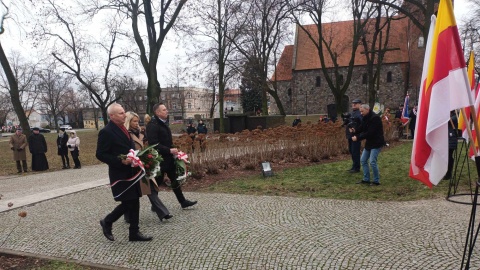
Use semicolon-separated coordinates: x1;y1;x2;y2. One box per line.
271;15;426;115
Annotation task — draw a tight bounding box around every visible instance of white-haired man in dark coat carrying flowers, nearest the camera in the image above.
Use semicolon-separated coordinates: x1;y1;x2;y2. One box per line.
96;103;152;241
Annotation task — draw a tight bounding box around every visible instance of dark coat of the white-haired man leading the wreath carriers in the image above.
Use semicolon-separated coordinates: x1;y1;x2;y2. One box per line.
95;121;142;201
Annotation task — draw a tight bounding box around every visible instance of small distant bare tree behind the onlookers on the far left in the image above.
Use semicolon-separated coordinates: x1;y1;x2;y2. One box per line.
37;62;73;130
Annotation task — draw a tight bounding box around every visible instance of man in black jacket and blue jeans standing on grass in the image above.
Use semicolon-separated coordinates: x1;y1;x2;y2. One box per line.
350;104;385;186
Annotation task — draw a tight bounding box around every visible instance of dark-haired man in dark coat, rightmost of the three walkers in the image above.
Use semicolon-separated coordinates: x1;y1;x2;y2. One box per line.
147;103;200;208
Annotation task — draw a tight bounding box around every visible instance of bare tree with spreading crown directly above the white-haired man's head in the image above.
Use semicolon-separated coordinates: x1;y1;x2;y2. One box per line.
36;0;132;125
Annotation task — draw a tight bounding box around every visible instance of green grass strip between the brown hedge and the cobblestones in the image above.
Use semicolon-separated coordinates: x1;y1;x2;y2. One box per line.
203;142;476;201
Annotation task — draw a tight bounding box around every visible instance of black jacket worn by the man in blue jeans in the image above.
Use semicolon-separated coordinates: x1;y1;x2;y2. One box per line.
355;110;385;150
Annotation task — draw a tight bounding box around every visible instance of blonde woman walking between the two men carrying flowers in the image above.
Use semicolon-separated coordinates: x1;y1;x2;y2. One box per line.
123;112;173;223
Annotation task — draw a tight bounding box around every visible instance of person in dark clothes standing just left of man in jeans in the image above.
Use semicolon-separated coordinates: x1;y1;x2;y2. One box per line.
344;99;362;173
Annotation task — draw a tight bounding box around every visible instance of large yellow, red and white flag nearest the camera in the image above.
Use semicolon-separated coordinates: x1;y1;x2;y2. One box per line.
410;0;473;187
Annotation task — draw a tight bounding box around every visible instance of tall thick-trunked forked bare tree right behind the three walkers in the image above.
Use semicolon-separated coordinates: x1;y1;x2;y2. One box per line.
82;0;187;114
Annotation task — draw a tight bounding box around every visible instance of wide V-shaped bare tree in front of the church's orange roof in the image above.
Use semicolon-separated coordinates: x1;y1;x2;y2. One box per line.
288;0;375;112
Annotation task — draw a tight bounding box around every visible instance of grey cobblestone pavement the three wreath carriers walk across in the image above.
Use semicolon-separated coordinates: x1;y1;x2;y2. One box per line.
0;166;480;269
